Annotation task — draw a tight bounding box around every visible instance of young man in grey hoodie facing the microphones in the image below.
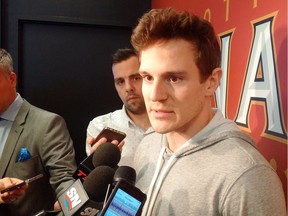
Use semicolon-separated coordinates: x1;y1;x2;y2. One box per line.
131;8;286;216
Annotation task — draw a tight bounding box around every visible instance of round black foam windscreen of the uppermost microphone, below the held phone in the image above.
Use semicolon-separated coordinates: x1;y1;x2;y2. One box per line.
92;142;121;168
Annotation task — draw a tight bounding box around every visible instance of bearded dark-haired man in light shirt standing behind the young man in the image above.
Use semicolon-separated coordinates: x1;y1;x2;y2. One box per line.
86;48;154;165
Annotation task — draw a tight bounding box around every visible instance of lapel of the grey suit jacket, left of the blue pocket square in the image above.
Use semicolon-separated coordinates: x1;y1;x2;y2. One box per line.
0;100;30;178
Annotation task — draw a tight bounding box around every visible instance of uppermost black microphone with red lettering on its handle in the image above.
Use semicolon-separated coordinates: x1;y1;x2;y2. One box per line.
73;142;121;182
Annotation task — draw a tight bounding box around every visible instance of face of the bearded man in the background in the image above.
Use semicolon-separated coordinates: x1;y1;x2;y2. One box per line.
112;56;146;114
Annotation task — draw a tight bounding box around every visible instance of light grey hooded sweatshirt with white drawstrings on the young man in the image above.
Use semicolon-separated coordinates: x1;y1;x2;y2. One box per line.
133;109;286;216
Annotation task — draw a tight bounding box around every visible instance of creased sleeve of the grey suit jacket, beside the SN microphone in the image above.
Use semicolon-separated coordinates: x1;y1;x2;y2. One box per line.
40;111;76;196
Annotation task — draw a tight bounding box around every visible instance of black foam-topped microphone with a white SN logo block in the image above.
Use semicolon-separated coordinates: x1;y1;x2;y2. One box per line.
58;166;115;216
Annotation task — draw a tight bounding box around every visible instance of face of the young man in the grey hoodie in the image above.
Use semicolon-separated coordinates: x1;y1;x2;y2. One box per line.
139;39;216;135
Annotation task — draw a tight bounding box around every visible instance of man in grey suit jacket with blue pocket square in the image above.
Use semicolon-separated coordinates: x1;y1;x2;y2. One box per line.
0;49;76;216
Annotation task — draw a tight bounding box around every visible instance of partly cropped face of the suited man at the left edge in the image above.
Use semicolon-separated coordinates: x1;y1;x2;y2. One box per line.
0;65;16;113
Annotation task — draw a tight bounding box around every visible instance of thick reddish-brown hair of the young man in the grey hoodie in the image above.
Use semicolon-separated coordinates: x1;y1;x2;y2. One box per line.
131;8;221;80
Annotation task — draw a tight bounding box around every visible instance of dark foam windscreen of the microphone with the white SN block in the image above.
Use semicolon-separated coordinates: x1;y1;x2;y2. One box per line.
83;166;115;202
